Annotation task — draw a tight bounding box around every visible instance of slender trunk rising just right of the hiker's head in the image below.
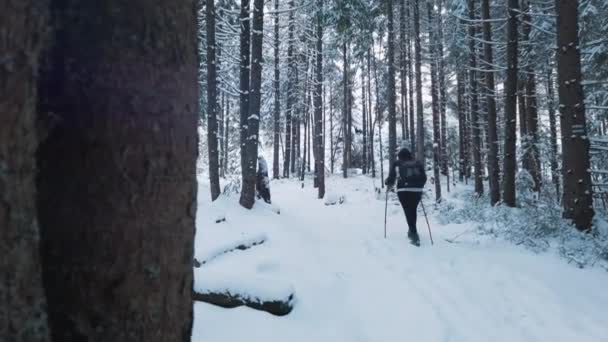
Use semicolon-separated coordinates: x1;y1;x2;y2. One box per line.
414;0;426;163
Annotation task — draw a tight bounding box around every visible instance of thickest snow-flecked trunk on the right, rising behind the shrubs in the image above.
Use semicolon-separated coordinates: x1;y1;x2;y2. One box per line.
555;0;594;231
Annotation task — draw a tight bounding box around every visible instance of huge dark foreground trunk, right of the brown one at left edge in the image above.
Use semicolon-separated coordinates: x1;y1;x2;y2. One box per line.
37;0;198;342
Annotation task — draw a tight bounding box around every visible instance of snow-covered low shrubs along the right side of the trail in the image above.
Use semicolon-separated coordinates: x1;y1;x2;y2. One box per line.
435;186;608;270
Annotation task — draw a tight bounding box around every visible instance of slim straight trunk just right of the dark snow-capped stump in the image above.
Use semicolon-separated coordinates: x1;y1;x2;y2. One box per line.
272;0;281;179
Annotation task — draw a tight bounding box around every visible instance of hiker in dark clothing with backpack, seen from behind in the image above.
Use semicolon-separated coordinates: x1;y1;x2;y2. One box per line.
384;148;426;245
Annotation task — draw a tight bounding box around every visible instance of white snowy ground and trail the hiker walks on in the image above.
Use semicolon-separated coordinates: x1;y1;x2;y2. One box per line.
193;178;608;342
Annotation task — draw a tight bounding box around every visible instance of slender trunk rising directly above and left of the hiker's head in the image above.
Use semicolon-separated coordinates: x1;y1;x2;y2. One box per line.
386;0;397;165
